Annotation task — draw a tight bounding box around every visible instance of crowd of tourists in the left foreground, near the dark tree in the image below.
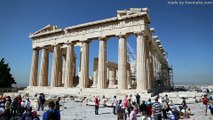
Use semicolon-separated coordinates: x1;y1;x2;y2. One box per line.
0;93;60;120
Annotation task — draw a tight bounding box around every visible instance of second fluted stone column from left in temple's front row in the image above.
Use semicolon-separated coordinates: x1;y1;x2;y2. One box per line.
39;48;49;86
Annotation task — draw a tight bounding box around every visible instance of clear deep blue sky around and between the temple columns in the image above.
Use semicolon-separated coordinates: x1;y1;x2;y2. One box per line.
0;0;213;84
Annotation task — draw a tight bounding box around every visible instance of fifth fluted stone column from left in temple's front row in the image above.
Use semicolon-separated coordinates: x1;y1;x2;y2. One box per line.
79;42;89;88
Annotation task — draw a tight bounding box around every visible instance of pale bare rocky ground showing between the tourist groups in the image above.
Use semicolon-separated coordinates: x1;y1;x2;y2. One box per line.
34;100;213;120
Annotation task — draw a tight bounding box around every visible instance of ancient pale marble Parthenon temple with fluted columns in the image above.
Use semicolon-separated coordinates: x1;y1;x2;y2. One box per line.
29;8;171;95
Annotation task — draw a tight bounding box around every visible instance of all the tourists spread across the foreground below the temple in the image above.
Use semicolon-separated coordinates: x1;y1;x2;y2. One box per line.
0;93;213;120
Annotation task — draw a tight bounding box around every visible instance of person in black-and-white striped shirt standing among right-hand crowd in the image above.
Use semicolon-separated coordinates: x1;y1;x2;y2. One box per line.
152;97;162;120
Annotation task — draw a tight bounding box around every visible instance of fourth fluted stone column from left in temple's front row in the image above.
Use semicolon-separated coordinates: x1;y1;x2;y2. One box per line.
64;44;74;87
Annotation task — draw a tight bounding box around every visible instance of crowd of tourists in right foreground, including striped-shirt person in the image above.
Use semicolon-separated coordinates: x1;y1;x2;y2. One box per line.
100;94;213;120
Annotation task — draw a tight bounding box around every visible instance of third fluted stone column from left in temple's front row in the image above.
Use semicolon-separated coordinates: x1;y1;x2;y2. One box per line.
51;45;60;87
